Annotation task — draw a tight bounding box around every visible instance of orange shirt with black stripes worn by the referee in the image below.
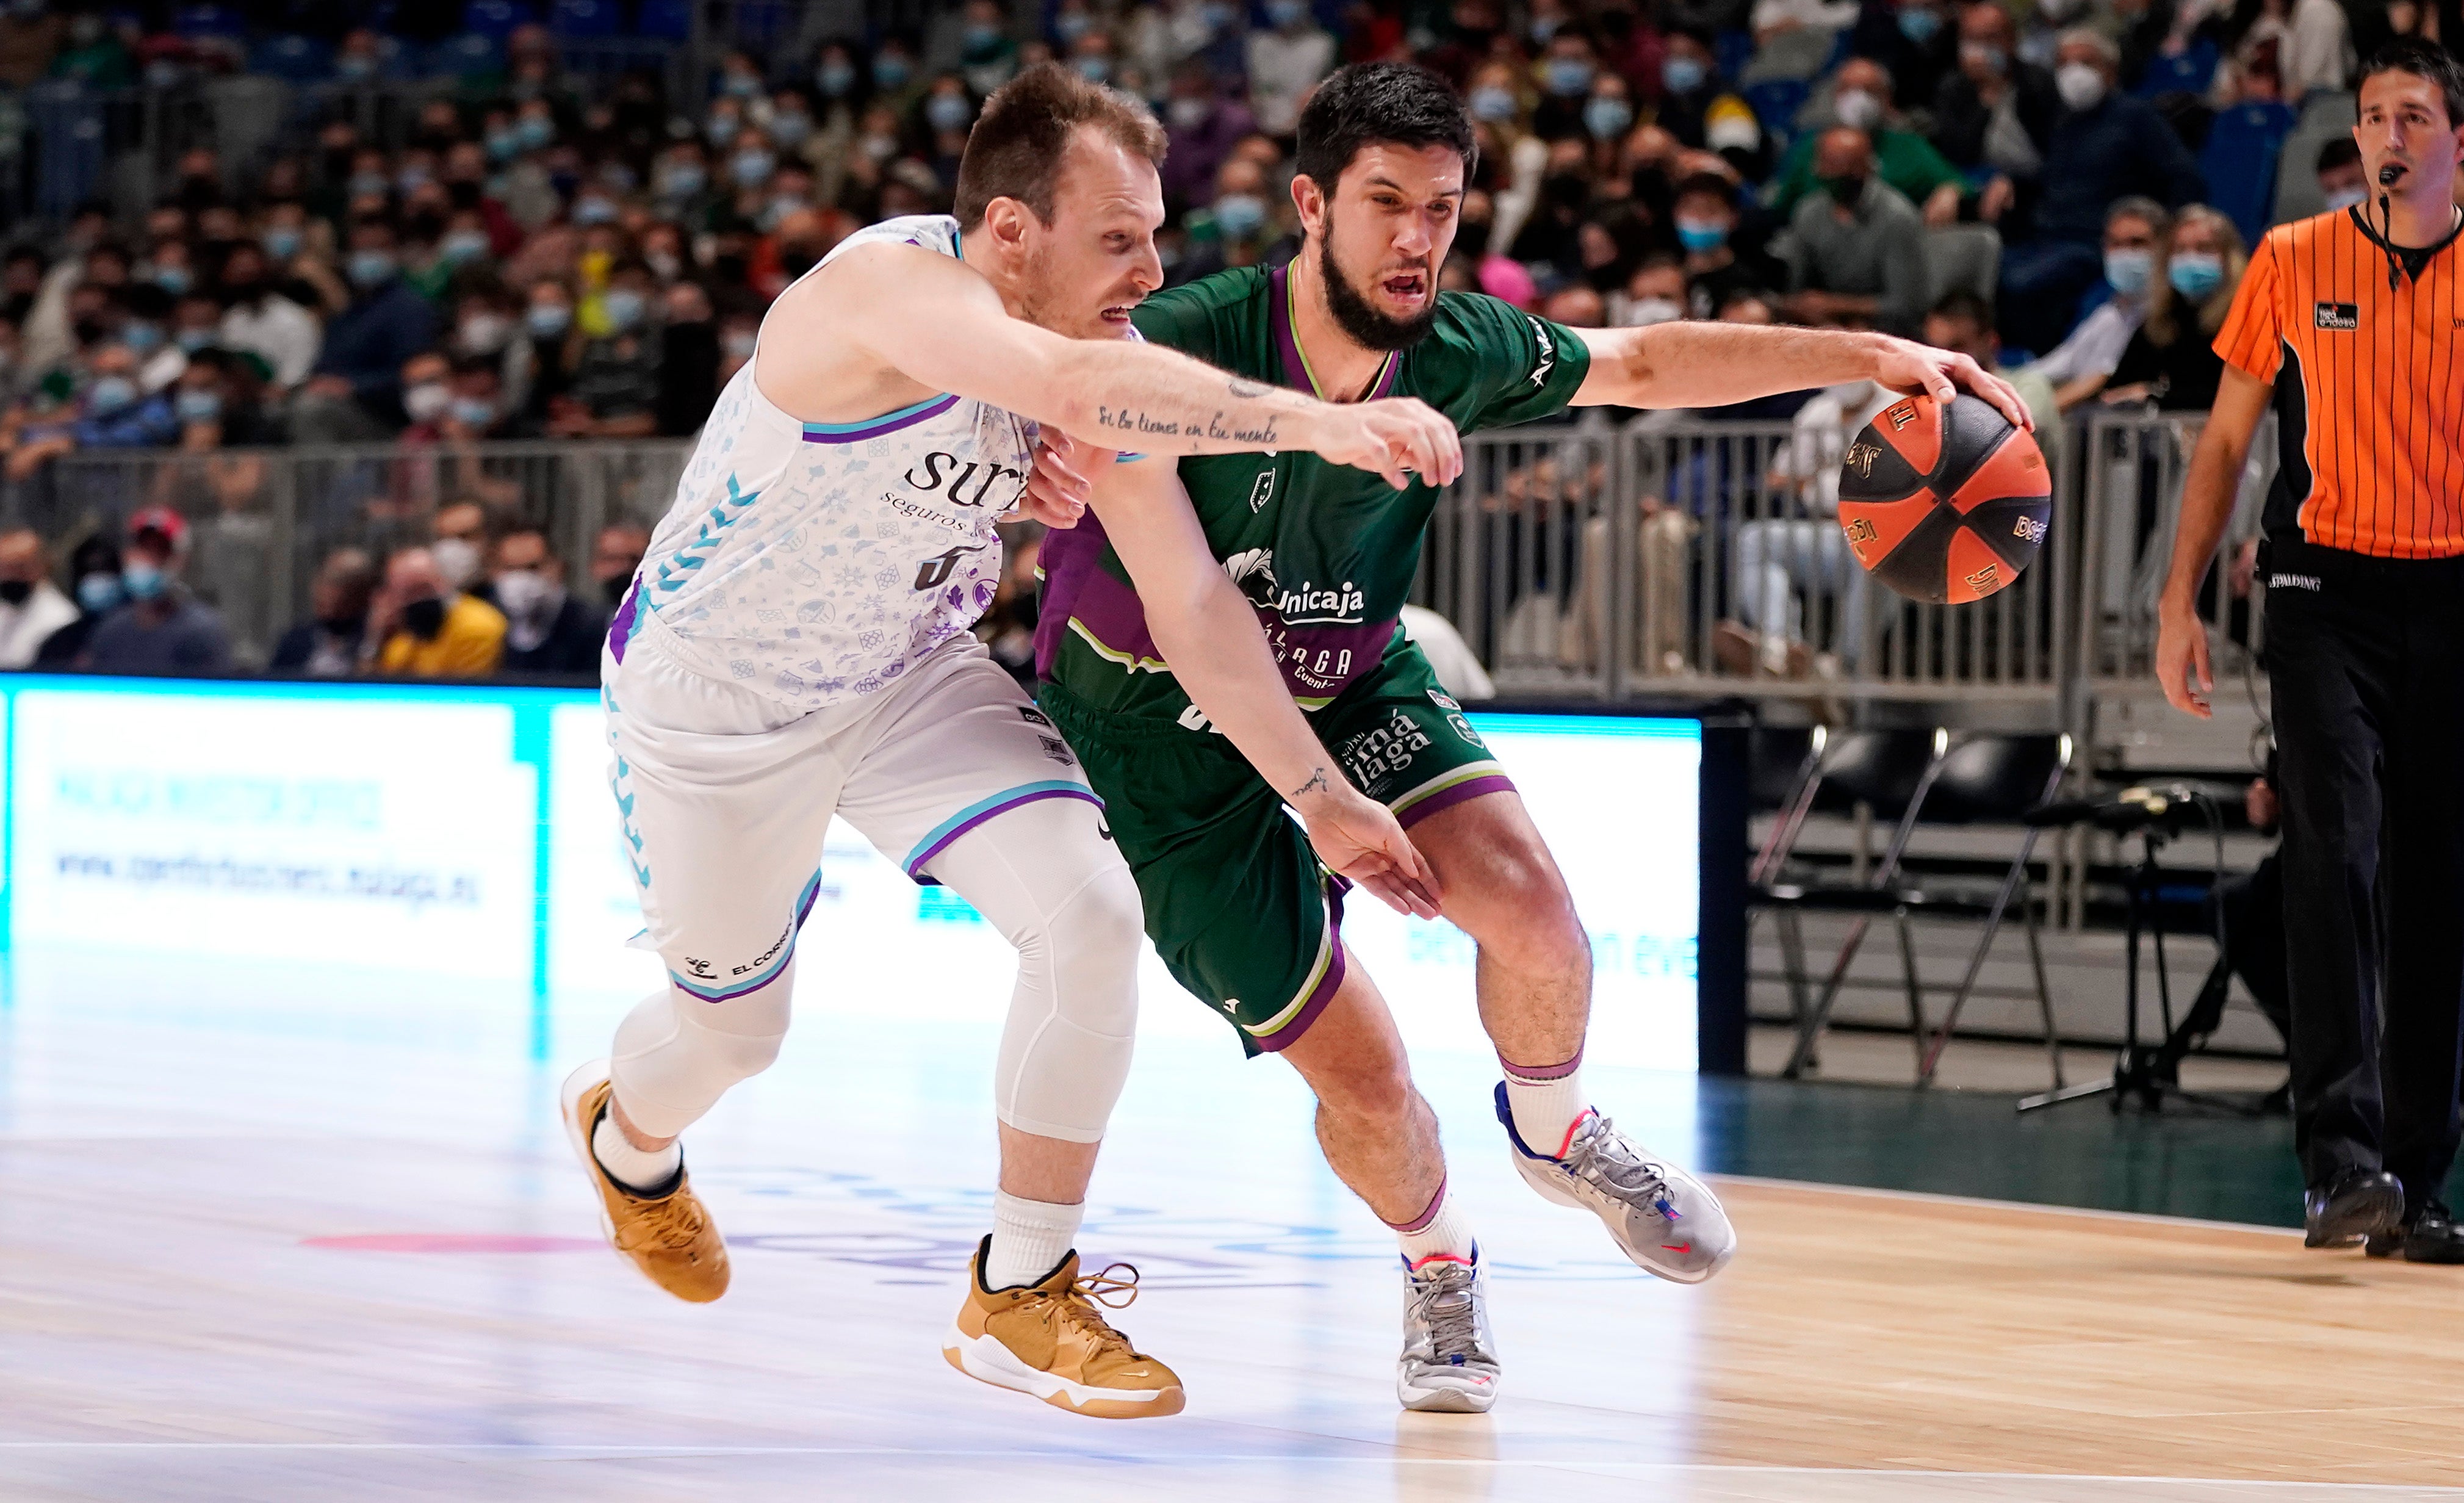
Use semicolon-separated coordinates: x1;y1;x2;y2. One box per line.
2215;209;2464;560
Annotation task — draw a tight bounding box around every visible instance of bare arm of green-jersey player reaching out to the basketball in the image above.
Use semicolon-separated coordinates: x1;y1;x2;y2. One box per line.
1574;320;2033;429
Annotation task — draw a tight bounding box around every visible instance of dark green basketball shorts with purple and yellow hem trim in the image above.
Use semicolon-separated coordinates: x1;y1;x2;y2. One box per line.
1037;636;1513;1054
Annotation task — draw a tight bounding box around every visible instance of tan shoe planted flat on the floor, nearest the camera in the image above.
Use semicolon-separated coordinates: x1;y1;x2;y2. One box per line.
942;1237;1183;1419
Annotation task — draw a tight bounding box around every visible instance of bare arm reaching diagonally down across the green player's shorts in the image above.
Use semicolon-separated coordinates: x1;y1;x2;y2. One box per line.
1079;436;1439;919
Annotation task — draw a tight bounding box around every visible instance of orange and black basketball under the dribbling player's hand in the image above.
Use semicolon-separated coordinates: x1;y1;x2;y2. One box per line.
1840;394;2053;606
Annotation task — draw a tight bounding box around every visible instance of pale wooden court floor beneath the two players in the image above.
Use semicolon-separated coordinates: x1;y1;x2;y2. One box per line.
0;961;2464;1503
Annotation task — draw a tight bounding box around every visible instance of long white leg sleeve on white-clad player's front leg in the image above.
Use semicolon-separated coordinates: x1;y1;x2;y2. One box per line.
926;798;1146;1143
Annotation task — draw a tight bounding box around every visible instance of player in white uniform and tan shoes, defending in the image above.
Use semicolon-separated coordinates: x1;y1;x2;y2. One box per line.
562;67;1461;1417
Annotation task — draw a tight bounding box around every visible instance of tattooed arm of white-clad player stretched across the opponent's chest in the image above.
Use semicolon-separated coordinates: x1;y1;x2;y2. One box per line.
813;244;1464;488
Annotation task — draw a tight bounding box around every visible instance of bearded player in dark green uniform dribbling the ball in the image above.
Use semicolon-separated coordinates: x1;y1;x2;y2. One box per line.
1037;64;2028;1410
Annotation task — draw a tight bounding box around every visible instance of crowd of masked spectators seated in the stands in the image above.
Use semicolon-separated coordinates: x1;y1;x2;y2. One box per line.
0;0;2464;675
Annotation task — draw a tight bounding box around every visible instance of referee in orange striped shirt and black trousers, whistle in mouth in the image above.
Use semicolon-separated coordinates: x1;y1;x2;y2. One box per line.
2156;42;2464;1264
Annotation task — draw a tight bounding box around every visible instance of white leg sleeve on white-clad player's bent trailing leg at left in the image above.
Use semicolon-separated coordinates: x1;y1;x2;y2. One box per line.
611;959;796;1138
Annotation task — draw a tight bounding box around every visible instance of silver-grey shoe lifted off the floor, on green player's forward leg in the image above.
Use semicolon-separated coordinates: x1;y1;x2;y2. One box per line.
1498;1082;1737;1284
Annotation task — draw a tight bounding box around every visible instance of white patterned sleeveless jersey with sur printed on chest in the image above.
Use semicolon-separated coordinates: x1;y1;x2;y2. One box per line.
625;217;1035;710
